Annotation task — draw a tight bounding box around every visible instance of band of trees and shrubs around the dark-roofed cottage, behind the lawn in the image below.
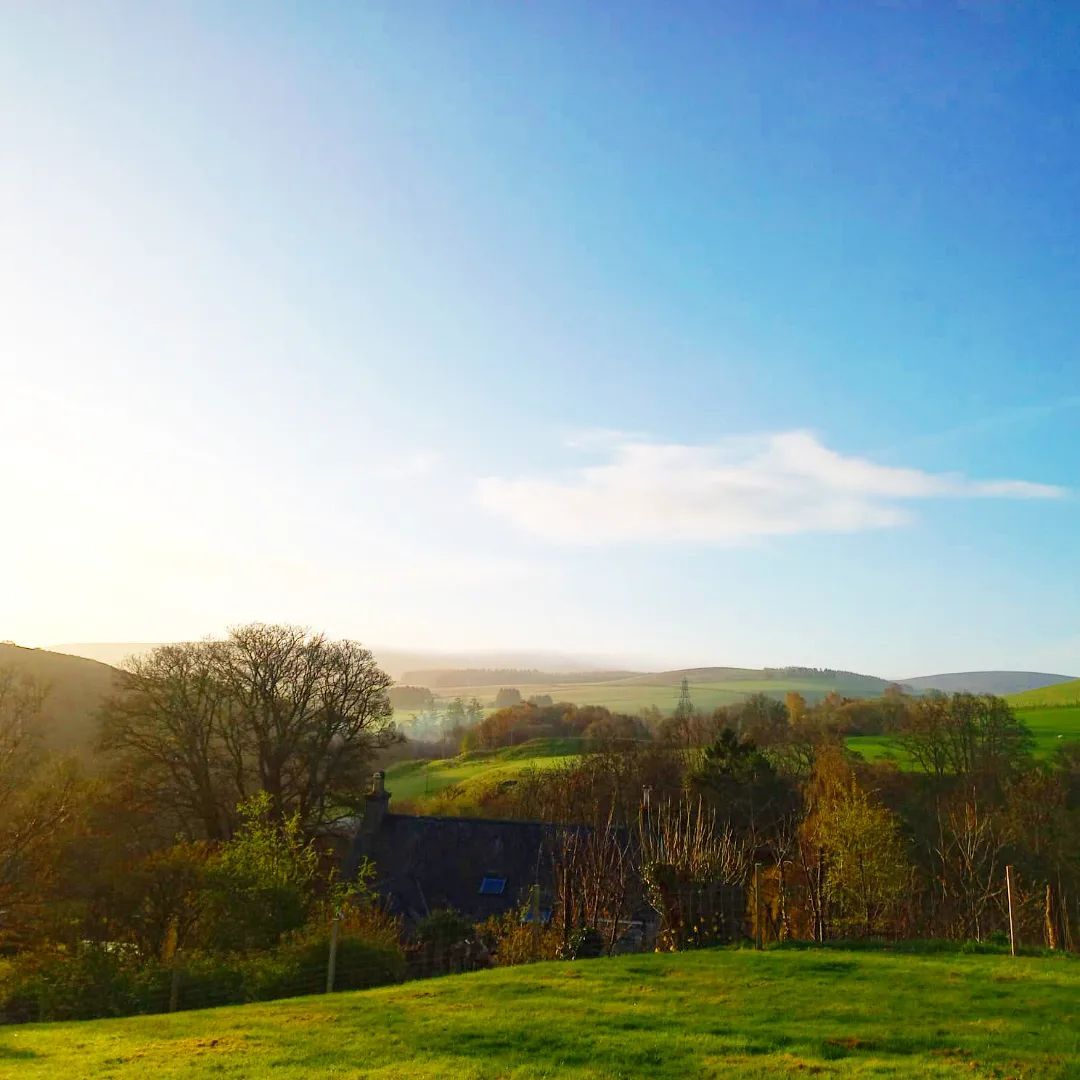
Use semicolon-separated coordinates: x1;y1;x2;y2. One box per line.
0;624;1080;1018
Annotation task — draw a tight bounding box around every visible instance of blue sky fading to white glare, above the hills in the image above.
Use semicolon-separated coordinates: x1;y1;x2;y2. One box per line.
0;0;1080;677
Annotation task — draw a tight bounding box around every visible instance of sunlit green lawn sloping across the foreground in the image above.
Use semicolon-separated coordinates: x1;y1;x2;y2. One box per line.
0;949;1080;1080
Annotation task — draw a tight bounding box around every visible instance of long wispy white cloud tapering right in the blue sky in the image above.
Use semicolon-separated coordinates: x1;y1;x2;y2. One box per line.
476;431;1066;544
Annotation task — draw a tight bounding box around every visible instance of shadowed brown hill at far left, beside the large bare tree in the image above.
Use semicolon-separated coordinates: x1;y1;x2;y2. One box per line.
0;643;120;752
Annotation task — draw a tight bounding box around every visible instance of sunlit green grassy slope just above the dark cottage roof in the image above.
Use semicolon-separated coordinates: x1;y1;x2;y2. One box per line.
387;739;581;802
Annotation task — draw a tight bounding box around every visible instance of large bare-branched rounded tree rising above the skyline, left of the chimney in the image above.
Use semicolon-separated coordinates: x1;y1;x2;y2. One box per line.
103;623;399;839
